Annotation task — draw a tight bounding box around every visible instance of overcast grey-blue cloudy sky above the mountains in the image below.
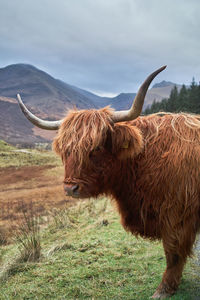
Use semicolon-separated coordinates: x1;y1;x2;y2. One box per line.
0;0;200;95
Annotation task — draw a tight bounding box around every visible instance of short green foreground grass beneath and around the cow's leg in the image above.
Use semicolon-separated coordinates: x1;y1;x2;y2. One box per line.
0;199;200;300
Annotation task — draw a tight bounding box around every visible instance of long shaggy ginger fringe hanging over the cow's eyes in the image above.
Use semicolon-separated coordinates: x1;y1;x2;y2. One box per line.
53;107;113;171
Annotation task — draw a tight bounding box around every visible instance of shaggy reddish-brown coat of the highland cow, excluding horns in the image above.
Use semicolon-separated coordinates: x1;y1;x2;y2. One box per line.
53;108;200;298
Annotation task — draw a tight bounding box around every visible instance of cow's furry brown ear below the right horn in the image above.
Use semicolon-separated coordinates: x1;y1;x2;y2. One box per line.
111;123;143;159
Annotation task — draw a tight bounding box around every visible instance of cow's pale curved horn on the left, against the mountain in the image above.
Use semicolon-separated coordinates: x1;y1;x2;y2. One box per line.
17;94;63;130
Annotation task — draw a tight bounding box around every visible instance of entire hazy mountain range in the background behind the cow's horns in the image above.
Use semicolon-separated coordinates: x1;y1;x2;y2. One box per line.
0;64;178;144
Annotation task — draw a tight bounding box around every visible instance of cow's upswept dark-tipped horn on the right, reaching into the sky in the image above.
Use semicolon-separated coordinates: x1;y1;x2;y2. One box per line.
112;66;167;123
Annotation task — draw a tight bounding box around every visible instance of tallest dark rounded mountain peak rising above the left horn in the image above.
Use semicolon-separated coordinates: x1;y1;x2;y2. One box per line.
0;64;99;119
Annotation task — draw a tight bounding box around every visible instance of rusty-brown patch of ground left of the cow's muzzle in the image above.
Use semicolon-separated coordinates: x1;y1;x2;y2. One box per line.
0;165;78;240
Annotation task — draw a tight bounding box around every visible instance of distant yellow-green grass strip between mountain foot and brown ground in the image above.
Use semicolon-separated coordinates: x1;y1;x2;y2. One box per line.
0;140;60;168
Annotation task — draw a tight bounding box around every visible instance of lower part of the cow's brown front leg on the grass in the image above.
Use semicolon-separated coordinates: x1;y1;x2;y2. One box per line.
152;251;186;299
